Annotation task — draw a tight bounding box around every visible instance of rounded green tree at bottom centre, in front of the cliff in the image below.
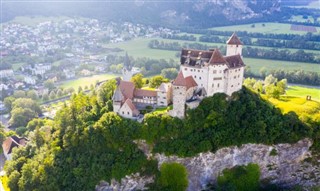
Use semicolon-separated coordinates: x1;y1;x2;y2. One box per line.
160;163;188;191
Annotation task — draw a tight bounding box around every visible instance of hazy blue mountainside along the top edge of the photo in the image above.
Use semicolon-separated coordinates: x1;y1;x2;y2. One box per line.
2;0;281;27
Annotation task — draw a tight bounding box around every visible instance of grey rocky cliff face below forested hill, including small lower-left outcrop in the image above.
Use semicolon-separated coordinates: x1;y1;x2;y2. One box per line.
97;139;320;191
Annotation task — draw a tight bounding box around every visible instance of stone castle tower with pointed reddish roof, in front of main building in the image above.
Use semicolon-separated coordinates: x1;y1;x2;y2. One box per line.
170;71;187;118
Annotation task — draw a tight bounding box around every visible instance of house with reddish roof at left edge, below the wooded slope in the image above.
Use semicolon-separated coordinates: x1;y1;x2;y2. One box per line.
2;135;28;160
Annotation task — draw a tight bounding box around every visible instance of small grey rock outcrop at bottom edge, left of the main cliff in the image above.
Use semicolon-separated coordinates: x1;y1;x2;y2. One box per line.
96;173;154;191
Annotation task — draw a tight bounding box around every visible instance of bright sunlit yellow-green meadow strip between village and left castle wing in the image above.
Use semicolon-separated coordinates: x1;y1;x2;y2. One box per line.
60;74;118;90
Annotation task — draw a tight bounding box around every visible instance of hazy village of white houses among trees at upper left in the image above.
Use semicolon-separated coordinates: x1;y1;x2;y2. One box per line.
0;18;174;114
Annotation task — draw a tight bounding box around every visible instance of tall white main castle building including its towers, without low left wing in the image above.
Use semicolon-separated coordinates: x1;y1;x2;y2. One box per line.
170;33;245;118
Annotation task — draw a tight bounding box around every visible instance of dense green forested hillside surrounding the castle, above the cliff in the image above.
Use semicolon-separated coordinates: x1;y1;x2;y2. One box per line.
5;80;319;191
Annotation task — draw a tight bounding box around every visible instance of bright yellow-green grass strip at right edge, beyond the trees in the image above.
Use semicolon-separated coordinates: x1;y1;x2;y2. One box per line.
286;86;320;102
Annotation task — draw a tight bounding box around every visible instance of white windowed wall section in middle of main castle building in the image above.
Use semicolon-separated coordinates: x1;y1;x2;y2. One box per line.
206;64;227;96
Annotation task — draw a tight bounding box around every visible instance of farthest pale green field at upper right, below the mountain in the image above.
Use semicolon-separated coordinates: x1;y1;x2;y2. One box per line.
211;23;320;34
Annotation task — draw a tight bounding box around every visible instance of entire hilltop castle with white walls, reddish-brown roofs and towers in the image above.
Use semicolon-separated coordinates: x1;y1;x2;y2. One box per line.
113;33;245;118
